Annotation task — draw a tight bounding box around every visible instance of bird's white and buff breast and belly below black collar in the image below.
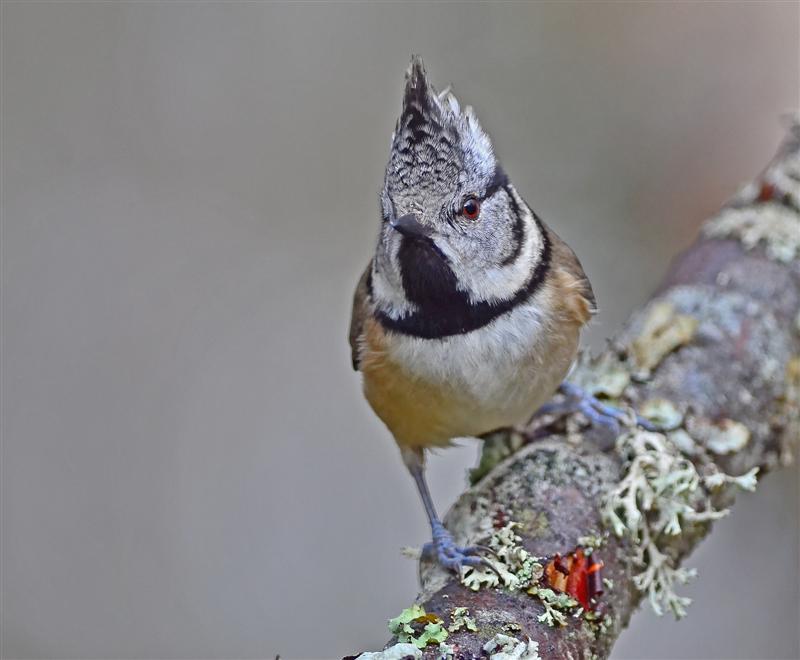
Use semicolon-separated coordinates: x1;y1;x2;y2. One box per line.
361;294;580;447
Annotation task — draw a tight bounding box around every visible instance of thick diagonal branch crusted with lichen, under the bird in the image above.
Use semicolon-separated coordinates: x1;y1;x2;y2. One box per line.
354;124;800;660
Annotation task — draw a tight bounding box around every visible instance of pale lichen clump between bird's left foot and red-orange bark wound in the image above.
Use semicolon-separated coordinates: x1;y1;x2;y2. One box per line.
461;522;544;591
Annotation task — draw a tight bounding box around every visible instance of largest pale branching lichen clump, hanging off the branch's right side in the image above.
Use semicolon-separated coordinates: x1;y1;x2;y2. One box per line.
602;430;755;618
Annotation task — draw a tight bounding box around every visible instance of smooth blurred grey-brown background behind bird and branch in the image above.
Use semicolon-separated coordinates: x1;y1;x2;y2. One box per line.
2;2;800;659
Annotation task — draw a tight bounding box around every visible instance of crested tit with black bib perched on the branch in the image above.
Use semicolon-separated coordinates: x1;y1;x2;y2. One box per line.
349;55;619;571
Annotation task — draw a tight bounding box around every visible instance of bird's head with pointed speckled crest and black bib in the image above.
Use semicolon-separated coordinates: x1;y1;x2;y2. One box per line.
371;56;548;338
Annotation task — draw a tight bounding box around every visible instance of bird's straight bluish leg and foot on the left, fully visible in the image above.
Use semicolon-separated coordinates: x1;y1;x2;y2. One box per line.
401;449;495;573
